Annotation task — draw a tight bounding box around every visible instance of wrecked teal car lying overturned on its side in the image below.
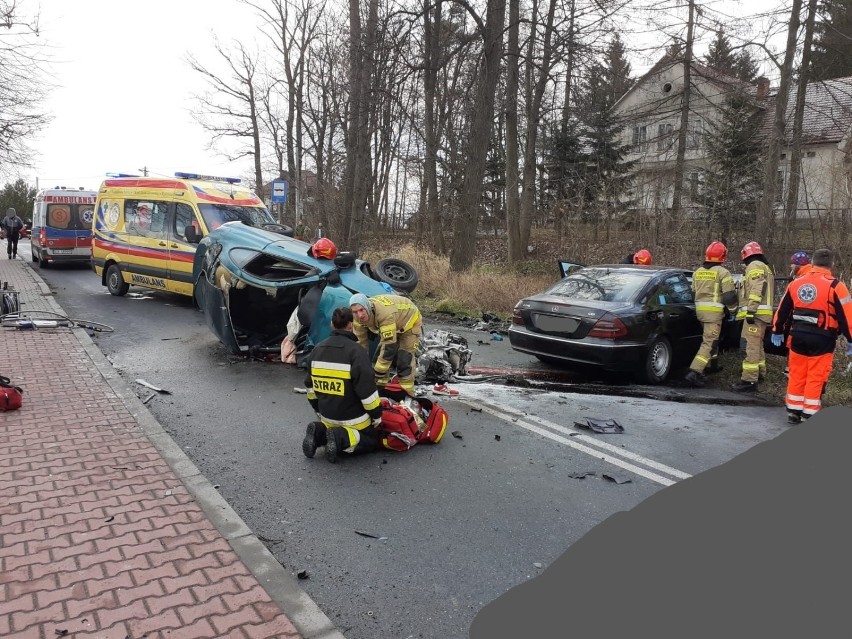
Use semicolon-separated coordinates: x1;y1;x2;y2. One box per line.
192;222;418;365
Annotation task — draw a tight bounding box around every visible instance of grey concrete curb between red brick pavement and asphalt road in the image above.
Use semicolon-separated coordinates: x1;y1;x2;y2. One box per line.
22;260;346;639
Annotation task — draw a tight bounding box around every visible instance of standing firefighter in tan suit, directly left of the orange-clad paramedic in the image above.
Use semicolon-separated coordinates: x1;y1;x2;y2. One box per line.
732;242;775;393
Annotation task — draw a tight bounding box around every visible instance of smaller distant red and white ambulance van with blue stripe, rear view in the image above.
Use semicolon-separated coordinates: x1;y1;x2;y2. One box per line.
30;186;98;268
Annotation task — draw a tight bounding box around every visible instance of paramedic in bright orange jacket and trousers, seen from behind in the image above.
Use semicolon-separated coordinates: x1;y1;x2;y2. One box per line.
772;249;852;424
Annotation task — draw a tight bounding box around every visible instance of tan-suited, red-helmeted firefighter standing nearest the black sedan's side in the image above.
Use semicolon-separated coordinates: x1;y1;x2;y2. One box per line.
686;242;737;387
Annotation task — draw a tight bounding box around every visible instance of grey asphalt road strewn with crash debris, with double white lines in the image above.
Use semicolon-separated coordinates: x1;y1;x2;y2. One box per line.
26;246;786;639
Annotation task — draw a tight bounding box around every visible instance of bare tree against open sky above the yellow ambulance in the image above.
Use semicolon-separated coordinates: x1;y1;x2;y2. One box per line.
187;40;263;193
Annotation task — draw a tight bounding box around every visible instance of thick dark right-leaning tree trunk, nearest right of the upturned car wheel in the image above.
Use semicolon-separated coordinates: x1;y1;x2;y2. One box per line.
450;0;506;272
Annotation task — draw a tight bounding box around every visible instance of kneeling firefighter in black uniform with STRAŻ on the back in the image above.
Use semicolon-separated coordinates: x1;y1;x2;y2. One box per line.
302;306;382;464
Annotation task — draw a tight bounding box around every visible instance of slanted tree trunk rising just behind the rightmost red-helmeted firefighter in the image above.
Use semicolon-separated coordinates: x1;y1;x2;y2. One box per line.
756;0;802;246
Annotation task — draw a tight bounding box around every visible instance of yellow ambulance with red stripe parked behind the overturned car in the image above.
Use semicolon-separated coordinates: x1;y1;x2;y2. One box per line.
92;173;288;296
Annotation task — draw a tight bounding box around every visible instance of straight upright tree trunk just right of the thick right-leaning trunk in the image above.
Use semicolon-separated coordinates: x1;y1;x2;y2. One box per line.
506;0;524;264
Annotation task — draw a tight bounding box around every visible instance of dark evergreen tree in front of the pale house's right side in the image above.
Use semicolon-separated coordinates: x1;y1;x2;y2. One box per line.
694;94;763;242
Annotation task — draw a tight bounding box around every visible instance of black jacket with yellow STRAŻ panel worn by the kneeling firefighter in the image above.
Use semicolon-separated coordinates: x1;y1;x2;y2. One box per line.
305;330;382;430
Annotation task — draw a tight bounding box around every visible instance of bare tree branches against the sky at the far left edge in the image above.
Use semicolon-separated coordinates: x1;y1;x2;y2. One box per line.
0;0;50;174
